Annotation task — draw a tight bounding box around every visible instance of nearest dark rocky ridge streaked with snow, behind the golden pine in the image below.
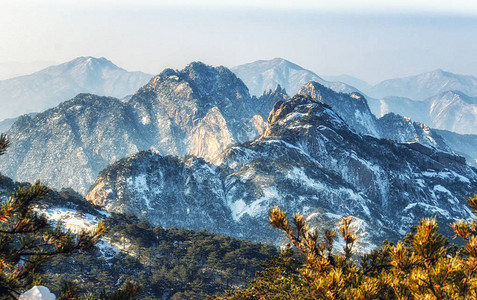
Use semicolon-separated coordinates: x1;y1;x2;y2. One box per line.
87;96;477;247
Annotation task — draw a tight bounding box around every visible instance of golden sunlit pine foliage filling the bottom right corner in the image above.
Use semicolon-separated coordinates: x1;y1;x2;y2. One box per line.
220;195;477;299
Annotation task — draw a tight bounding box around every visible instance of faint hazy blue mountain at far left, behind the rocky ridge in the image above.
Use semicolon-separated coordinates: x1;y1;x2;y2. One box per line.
0;57;152;120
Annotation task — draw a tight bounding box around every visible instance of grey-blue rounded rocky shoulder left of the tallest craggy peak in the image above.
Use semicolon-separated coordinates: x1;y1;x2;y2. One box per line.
0;94;141;192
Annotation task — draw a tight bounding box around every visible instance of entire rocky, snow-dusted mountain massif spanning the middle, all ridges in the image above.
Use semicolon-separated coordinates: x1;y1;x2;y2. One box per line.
0;58;477;248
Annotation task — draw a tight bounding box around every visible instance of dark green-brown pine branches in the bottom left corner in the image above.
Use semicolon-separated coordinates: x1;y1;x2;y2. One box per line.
0;135;105;299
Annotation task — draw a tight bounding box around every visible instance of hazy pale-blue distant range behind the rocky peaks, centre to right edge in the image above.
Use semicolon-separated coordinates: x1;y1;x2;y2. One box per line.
232;58;477;134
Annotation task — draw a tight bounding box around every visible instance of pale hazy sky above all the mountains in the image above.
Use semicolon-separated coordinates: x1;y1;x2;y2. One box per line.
0;0;477;83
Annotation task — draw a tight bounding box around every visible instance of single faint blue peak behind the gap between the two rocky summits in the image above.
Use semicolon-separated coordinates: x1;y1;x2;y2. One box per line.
231;58;357;96
